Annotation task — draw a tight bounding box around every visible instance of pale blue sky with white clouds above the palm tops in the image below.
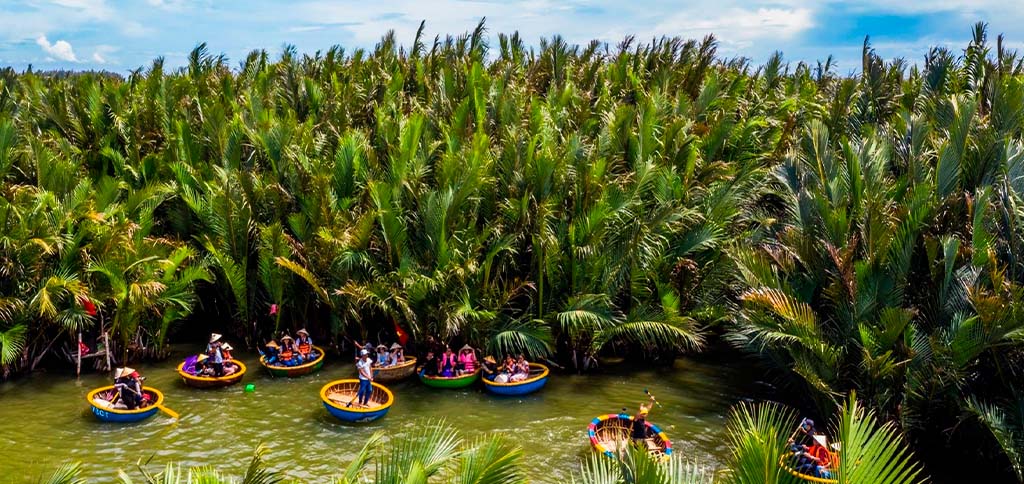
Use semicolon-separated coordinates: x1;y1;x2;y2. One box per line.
0;0;1024;74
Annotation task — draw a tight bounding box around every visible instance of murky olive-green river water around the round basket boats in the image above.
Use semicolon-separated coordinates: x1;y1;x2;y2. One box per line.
0;349;755;482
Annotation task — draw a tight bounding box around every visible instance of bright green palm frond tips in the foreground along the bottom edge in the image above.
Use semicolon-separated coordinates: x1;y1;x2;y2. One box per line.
40;398;922;484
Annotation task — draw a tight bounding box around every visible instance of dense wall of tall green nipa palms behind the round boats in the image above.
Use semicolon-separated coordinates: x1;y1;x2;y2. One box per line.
0;17;1024;482
